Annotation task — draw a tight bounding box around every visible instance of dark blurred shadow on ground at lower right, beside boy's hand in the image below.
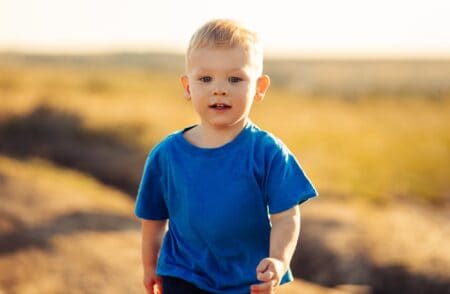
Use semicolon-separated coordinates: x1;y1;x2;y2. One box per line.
292;219;450;294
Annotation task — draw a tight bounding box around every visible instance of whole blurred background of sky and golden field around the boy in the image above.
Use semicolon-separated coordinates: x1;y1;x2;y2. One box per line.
0;0;450;294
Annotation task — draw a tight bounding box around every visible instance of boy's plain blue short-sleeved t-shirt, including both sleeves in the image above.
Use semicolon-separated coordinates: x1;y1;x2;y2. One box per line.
135;121;318;293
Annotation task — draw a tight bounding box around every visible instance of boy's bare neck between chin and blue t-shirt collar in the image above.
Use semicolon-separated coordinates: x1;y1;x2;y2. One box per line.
184;119;249;148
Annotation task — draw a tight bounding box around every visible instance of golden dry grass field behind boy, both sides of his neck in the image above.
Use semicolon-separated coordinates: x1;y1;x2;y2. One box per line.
0;63;450;204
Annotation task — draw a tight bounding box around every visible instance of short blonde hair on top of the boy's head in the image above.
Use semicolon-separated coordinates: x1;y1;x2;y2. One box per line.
186;19;263;75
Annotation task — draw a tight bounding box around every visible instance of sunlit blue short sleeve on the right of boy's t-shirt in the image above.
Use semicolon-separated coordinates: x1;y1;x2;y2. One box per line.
265;142;318;214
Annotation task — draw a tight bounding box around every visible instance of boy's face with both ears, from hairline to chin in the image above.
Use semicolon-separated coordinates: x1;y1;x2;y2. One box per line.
181;47;269;128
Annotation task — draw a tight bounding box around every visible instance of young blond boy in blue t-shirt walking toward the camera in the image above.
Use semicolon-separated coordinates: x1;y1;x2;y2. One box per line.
135;20;317;294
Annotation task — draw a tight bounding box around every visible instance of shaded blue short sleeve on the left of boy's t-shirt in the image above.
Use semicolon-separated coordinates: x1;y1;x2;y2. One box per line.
134;150;168;220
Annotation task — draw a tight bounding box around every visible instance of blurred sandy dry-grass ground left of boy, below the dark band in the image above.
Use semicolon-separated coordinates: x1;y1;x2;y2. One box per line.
0;157;140;293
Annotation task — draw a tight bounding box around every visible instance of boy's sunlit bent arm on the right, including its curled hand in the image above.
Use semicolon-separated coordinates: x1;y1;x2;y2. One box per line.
251;205;300;292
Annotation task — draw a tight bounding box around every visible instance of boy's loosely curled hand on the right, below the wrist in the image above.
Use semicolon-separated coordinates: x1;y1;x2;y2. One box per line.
250;257;286;294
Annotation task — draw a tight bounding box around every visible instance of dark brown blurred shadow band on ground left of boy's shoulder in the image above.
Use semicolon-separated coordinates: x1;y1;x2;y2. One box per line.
0;105;147;197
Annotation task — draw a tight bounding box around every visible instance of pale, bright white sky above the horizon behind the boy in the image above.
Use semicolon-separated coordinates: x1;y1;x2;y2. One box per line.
0;0;450;57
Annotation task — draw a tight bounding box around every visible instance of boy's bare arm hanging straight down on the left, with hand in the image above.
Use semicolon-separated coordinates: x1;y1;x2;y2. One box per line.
141;220;167;294
